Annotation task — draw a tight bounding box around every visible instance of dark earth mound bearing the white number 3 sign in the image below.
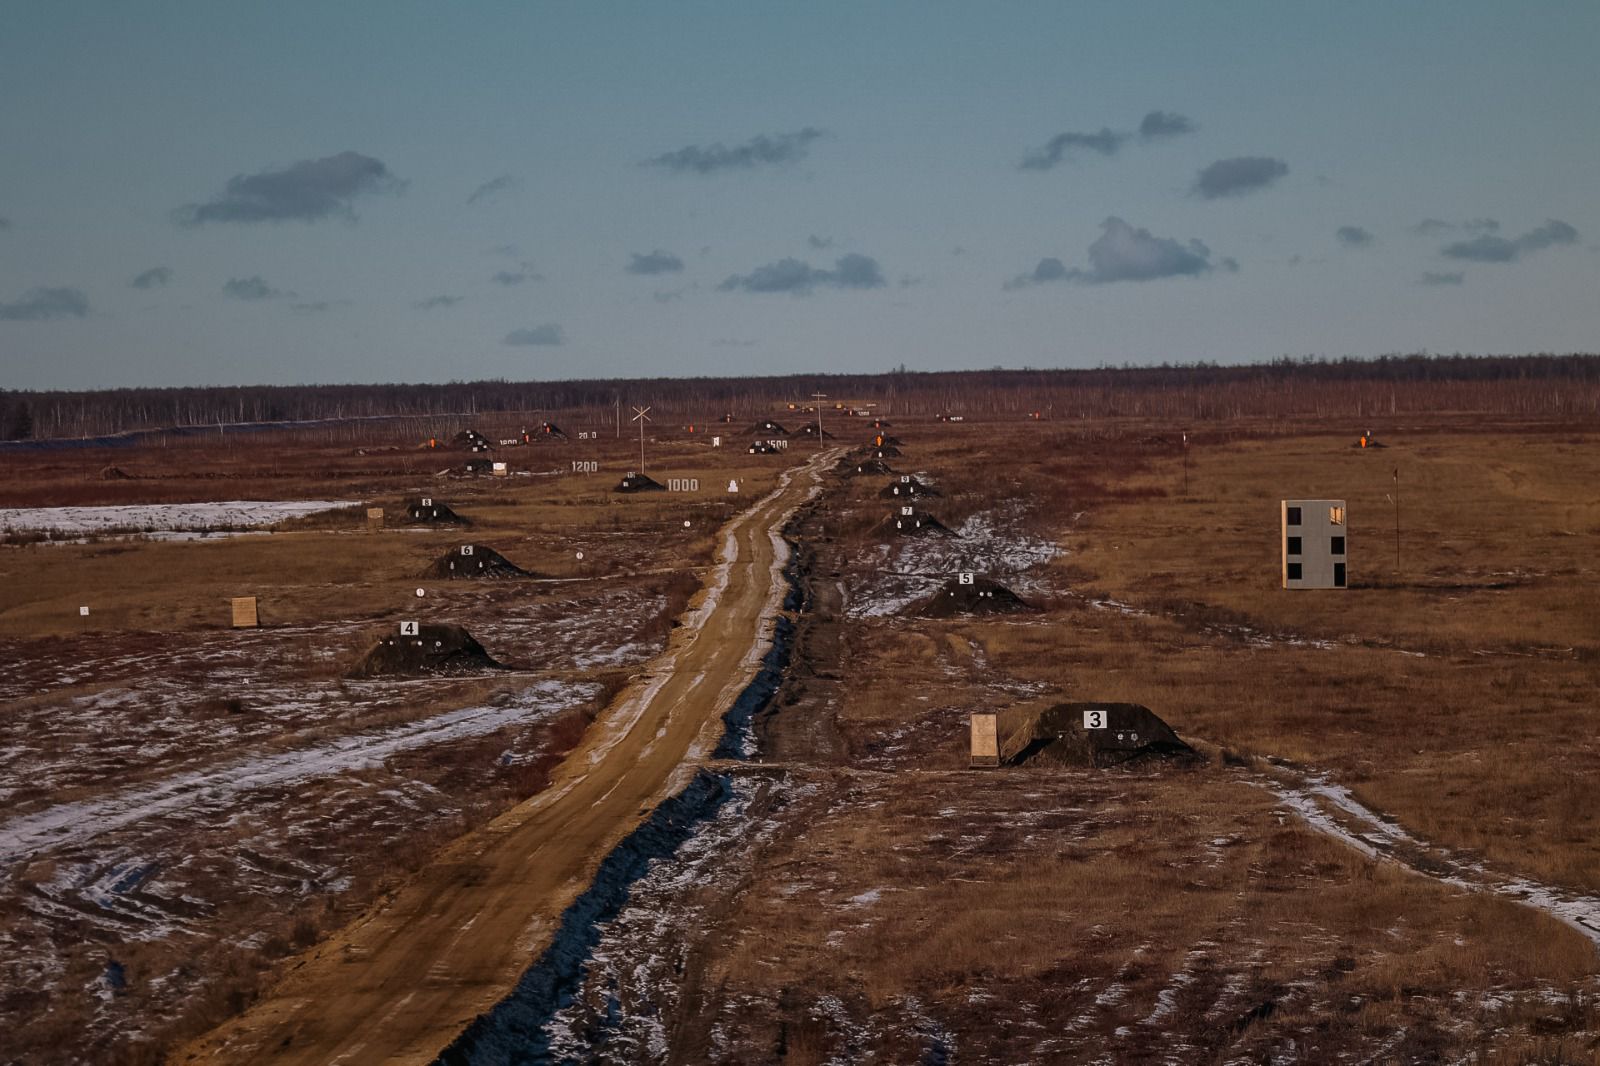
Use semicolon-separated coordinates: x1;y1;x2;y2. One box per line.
1008;703;1200;767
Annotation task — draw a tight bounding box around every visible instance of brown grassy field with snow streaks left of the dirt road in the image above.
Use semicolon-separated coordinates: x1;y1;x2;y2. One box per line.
0;419;800;1064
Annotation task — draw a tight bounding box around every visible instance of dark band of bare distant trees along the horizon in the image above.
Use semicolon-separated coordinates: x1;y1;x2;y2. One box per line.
0;354;1600;440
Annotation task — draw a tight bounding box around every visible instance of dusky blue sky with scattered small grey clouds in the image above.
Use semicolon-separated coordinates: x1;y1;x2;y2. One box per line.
0;0;1600;389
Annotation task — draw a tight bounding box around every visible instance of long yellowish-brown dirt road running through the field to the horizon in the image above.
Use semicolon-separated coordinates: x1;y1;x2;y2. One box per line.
170;450;838;1066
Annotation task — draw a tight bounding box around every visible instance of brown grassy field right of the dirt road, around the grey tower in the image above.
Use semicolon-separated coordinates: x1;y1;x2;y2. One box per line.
716;416;1600;1063
